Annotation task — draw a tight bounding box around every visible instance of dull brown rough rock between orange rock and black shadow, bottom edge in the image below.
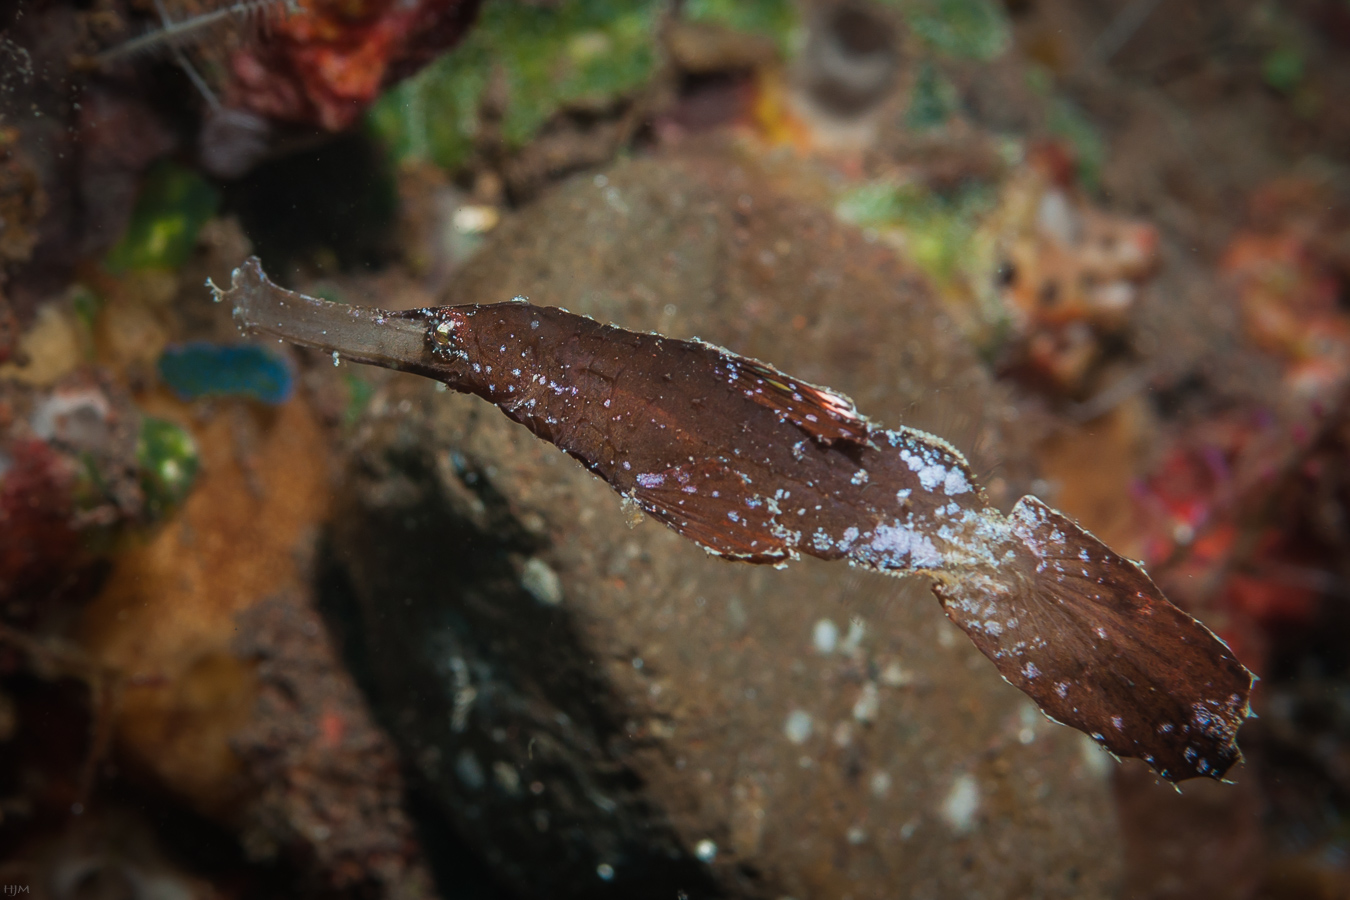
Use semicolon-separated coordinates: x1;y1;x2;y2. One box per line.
231;595;433;900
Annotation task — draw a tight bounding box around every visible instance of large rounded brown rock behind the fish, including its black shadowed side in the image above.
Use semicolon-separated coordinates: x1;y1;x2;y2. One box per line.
329;154;1121;899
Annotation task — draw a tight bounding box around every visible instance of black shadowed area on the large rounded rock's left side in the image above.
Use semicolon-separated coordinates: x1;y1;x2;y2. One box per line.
321;429;720;897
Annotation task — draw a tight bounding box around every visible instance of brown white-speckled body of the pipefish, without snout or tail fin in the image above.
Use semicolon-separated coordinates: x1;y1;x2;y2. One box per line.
428;304;1013;572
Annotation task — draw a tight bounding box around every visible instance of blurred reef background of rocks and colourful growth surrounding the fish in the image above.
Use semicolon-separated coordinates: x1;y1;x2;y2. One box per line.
0;0;1350;900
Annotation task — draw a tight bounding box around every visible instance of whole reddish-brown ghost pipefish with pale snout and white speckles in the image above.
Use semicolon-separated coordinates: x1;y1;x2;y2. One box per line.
211;259;1253;781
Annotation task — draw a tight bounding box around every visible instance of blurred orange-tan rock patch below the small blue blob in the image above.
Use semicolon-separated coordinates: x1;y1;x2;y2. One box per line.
81;401;327;815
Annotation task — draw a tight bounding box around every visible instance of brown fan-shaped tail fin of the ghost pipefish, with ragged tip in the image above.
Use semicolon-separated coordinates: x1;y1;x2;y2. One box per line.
933;497;1253;781
